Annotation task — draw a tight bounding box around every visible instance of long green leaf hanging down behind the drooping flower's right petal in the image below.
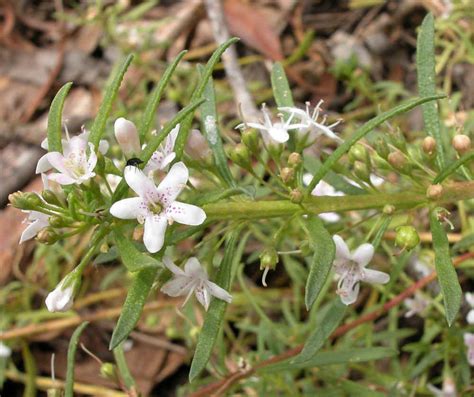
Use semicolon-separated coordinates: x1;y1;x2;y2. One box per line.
189;230;240;382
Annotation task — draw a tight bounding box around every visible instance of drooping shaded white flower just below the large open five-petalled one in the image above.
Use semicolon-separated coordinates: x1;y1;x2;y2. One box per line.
161;257;232;310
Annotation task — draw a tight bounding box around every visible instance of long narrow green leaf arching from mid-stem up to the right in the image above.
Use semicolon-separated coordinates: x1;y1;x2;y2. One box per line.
306;95;444;195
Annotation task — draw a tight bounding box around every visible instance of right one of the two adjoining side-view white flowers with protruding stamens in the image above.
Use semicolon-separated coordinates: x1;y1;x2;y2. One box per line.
278;100;342;141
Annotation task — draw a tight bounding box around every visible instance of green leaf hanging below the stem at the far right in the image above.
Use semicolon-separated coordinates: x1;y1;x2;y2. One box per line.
430;208;462;326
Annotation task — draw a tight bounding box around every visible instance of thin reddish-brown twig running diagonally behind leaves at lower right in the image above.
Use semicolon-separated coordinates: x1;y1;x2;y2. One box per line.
189;252;474;397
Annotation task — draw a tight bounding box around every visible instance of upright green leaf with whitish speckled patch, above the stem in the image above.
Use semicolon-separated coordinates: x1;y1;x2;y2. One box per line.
200;66;237;187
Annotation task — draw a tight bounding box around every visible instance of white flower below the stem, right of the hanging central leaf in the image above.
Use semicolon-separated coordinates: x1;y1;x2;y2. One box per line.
333;234;390;305
